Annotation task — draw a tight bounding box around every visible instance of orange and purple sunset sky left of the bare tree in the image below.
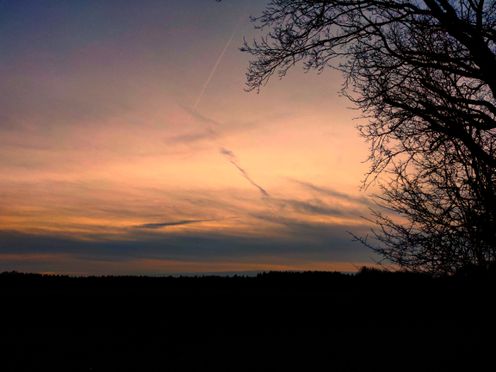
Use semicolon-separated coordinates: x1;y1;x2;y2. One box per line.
0;0;375;275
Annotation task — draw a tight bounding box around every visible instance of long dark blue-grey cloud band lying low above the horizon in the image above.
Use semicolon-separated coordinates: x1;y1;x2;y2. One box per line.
0;219;370;264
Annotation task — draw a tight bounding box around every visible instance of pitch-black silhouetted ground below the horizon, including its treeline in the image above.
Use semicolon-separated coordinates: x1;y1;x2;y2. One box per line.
0;270;496;371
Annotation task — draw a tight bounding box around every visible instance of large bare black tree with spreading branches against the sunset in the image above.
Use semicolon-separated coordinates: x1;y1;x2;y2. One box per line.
242;0;496;273
